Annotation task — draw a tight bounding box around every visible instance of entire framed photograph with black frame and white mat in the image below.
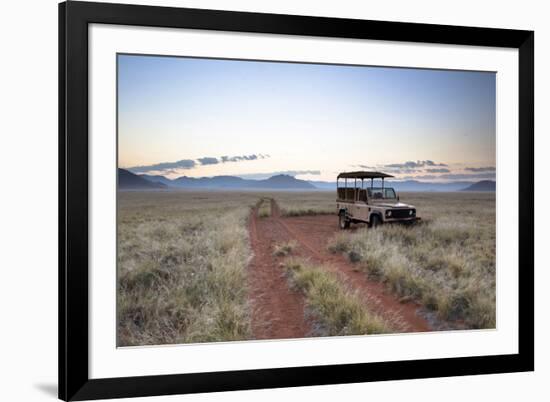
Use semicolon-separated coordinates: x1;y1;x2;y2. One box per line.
59;1;534;400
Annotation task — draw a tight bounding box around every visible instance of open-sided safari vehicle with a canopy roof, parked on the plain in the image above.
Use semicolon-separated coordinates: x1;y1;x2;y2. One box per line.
336;171;420;229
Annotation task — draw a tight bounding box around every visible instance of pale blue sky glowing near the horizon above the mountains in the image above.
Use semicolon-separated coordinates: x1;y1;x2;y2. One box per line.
118;55;496;181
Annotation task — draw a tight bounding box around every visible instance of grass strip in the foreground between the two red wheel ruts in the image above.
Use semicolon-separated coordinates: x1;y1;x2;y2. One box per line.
285;259;393;336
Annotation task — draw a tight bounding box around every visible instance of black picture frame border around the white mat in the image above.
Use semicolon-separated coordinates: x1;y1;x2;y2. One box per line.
59;1;534;400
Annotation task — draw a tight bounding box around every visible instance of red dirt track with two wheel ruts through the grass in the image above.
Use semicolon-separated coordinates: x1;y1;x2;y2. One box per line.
249;201;431;339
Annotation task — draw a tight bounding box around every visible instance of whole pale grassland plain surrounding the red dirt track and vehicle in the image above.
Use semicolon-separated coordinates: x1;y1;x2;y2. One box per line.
117;191;496;346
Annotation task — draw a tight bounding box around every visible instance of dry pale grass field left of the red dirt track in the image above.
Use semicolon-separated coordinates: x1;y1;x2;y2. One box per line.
117;191;257;346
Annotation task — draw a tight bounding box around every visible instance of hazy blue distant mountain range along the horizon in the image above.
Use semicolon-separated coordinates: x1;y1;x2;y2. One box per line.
118;169;496;191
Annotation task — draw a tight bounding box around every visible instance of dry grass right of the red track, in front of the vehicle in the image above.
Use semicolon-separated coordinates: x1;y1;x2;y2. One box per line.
329;193;496;328
